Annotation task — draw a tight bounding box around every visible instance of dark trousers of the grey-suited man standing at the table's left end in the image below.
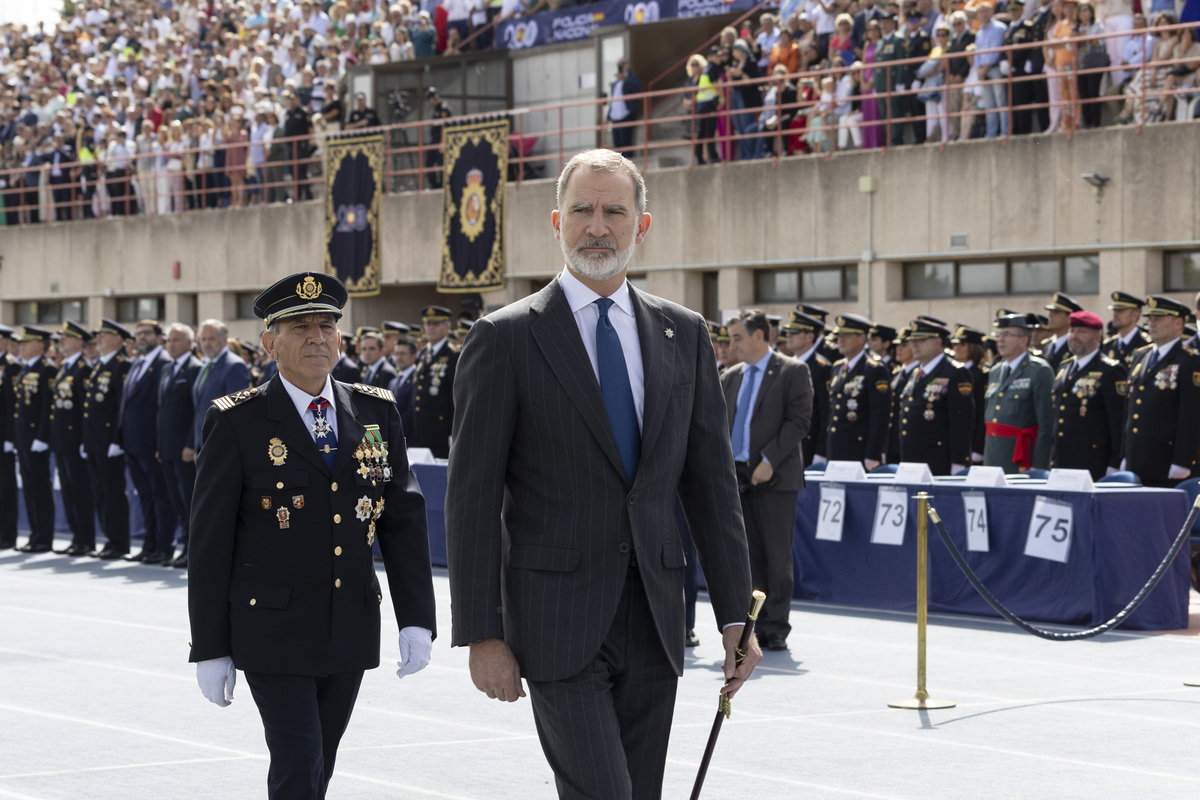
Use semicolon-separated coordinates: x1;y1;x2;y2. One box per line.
737;463;799;639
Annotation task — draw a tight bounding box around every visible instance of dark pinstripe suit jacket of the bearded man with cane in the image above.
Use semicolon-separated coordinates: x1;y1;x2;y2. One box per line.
446;281;750;681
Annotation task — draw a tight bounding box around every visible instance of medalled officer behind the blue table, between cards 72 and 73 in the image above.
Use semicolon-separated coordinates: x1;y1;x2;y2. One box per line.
826;314;890;471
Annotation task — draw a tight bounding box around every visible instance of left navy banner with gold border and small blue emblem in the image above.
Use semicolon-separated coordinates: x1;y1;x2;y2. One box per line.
325;134;384;297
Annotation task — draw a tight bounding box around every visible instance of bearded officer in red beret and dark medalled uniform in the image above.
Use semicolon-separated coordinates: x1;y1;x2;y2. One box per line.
1050;311;1129;480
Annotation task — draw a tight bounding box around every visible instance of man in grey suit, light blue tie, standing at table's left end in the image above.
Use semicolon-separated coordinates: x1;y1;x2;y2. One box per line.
721;309;812;650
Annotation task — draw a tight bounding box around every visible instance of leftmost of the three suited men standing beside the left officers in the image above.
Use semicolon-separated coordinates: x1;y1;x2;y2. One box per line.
121;319;179;564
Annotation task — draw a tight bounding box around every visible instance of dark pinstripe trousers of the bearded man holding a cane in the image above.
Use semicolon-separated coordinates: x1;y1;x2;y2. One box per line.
527;567;679;800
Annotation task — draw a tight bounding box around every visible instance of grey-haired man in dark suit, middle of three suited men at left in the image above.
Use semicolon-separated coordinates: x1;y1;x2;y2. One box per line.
157;323;200;569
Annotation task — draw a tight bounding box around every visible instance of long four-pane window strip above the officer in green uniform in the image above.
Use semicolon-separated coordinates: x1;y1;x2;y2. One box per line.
904;253;1100;300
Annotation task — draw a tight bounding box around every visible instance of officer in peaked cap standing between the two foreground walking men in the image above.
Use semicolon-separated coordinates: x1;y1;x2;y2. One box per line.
408;306;462;458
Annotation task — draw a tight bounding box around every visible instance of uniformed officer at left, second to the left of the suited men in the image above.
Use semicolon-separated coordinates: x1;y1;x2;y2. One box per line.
50;321;96;555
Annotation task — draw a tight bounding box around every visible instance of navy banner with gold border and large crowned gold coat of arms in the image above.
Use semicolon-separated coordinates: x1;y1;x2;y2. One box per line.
438;120;509;294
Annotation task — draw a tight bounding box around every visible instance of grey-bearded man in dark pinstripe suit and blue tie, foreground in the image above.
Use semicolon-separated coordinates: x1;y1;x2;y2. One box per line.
446;150;762;800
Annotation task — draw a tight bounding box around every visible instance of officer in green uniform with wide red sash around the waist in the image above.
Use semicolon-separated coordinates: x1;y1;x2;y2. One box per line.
983;314;1054;473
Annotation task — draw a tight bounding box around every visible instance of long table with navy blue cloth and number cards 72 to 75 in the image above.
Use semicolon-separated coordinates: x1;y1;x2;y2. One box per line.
793;475;1190;631
